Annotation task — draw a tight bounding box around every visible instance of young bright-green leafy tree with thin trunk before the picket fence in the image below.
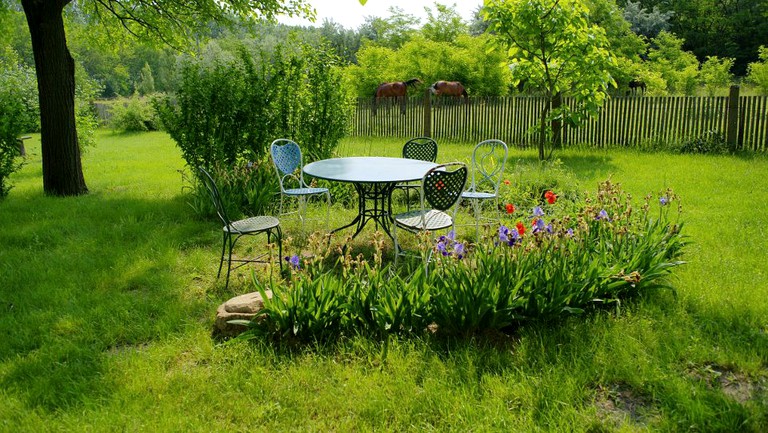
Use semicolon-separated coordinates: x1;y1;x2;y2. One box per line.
485;0;615;160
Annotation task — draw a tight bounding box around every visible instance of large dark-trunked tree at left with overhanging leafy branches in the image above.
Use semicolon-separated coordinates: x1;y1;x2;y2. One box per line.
15;0;310;196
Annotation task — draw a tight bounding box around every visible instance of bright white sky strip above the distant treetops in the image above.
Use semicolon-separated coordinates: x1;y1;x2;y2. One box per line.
278;0;483;29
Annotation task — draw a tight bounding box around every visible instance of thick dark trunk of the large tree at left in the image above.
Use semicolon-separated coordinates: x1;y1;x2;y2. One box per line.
21;0;88;196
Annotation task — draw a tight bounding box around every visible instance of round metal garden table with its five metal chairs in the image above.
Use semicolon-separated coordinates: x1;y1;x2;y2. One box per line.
198;137;508;287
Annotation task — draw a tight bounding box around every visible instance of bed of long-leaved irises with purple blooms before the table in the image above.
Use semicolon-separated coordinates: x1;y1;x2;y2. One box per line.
238;177;685;340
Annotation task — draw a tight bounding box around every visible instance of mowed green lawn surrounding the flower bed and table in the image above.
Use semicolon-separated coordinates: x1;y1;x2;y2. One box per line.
0;132;768;432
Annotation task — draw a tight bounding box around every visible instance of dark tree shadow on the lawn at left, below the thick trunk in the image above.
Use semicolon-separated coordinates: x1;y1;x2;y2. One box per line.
0;194;220;411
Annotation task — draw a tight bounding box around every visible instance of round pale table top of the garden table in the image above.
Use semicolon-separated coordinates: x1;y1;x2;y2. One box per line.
304;156;438;183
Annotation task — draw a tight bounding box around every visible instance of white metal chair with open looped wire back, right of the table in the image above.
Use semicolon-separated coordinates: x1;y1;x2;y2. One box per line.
460;140;509;241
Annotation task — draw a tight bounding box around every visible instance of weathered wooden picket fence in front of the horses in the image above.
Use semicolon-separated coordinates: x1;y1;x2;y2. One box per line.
352;88;768;152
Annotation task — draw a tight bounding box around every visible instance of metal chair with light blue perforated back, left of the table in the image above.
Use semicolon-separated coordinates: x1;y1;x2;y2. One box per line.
270;138;331;230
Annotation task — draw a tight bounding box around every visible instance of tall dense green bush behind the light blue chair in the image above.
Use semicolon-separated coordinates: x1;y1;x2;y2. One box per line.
156;41;349;168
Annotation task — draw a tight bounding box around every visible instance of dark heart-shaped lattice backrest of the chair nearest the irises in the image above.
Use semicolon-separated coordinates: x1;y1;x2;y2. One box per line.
421;162;467;211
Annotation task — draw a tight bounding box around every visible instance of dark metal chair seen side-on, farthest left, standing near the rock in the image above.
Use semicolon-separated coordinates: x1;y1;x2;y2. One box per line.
197;167;283;288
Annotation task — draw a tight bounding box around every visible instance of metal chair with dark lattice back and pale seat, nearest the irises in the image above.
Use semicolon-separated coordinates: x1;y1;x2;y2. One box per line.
392;162;467;266
